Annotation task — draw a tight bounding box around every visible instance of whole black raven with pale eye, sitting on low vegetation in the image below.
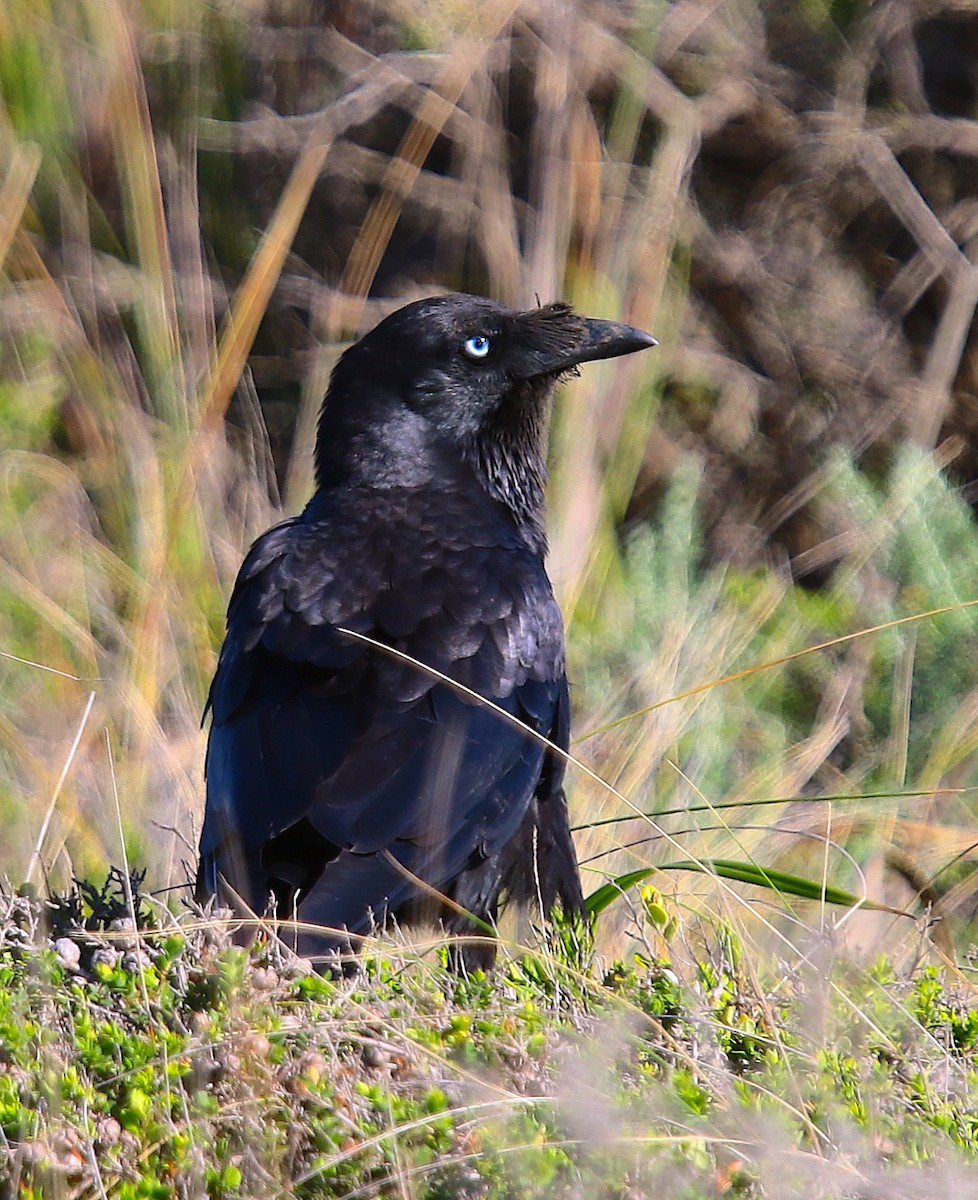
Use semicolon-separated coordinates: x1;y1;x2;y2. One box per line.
197;295;655;967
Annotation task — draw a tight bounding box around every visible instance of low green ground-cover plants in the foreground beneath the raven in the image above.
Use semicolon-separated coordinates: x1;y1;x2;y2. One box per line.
0;874;978;1200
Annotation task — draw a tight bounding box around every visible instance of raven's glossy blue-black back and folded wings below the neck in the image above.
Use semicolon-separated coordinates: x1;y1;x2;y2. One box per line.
198;492;566;932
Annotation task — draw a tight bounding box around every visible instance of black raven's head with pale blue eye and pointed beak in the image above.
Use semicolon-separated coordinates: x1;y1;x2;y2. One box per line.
316;294;655;546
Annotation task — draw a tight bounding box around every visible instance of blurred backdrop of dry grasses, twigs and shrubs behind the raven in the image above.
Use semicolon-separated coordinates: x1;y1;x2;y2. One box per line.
0;0;978;953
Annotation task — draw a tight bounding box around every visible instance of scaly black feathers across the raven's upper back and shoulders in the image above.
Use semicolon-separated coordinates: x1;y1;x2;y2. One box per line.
210;482;564;724
